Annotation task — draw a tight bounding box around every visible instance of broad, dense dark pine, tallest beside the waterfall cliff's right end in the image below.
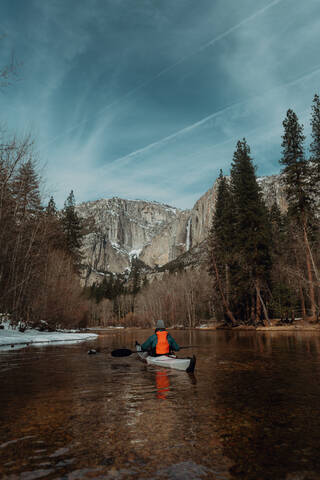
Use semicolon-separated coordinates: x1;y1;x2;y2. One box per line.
231;139;271;321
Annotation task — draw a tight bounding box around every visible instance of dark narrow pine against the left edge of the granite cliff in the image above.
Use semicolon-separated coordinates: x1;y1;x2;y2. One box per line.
62;190;83;269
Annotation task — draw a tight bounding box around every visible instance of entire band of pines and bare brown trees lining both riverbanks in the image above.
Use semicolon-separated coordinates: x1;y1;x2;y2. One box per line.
0;95;320;329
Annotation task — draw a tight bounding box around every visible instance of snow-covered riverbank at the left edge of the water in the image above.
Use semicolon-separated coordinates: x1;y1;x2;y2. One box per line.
0;322;98;350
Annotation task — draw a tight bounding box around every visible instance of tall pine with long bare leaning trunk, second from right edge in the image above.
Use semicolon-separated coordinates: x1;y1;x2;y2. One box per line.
280;107;317;317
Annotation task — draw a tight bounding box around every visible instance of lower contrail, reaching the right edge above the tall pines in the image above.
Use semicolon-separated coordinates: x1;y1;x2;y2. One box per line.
105;64;320;168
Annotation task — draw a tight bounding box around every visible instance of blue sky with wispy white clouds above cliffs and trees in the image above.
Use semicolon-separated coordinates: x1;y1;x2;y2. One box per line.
0;0;320;208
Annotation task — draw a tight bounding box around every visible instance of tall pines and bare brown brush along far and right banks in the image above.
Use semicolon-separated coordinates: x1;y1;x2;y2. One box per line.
90;95;320;327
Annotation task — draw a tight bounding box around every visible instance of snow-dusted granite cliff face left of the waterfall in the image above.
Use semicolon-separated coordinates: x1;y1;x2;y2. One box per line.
77;198;181;283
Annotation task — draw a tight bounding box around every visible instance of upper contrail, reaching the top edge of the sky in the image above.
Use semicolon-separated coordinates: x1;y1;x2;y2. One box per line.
42;0;283;149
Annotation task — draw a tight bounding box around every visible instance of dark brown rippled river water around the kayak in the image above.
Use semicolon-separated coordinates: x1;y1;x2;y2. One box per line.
0;330;320;480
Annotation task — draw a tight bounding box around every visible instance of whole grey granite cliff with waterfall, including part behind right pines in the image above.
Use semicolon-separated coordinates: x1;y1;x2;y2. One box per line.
77;175;286;284
